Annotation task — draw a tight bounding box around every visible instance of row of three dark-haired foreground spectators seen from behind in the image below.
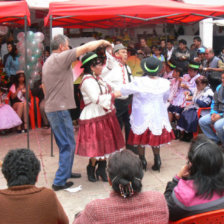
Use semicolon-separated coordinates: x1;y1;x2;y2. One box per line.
0;135;224;224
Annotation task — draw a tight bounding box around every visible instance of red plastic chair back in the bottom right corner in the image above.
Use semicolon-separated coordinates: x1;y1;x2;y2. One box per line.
169;209;224;224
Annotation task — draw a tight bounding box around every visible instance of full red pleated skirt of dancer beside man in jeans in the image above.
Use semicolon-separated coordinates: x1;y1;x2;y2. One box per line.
76;111;125;157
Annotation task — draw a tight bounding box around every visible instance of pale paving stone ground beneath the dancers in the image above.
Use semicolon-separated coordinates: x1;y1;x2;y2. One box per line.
0;129;189;223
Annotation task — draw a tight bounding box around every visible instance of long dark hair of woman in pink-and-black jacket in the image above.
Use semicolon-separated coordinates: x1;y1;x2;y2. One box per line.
188;135;224;198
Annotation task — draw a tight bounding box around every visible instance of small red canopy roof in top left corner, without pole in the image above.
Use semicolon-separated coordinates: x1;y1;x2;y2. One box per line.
0;1;30;26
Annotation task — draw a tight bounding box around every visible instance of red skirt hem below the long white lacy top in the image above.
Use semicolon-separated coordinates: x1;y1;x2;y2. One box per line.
128;128;175;146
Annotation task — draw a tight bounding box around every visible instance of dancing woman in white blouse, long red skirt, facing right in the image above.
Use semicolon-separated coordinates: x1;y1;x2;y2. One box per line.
76;52;124;182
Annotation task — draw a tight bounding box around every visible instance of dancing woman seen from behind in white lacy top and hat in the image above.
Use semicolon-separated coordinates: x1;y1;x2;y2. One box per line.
116;57;175;170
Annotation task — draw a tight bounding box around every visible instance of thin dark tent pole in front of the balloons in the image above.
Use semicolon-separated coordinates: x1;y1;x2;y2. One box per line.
24;16;30;149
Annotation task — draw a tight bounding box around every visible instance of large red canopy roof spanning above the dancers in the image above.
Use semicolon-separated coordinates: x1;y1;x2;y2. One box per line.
45;0;224;29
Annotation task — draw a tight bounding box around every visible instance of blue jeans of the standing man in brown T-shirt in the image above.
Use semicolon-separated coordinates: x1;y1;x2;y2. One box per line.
46;110;75;186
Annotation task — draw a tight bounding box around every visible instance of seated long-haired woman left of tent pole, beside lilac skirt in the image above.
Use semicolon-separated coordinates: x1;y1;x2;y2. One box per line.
9;70;27;133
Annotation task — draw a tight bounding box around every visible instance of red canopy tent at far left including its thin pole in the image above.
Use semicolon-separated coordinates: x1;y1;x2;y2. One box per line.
0;1;30;149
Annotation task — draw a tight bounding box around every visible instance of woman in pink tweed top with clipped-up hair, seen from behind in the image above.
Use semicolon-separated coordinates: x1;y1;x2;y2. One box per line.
73;150;169;224
